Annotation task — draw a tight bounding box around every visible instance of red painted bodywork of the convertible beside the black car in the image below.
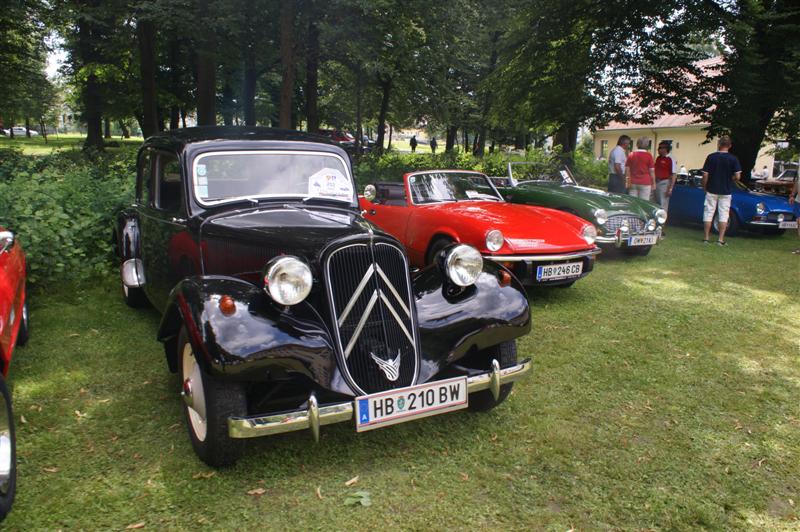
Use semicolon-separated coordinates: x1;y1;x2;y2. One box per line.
359;170;595;266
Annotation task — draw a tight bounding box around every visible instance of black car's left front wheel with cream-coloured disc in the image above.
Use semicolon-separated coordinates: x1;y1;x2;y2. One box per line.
178;327;247;467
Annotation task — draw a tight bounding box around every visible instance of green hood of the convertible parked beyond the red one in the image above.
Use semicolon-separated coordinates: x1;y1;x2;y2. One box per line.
507;183;658;218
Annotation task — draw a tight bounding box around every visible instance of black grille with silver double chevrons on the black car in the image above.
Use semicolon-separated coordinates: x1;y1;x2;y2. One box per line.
325;243;418;393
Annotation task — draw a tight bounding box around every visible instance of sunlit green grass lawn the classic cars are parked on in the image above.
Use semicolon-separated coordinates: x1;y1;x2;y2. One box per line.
5;228;800;531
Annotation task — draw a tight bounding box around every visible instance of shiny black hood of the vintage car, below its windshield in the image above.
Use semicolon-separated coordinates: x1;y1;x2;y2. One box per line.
202;206;382;266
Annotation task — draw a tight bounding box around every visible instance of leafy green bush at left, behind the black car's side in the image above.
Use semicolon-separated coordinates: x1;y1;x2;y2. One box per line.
0;149;136;285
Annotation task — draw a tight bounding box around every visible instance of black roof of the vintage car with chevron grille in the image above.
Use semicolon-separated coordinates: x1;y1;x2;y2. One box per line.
144;126;343;153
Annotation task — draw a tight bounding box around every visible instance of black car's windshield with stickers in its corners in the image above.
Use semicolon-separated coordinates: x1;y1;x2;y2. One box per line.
192;151;355;205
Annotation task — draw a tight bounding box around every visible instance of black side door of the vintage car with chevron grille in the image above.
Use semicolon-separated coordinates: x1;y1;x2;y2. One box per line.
139;150;188;310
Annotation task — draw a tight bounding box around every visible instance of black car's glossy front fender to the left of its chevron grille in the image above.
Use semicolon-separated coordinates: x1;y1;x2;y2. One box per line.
158;276;351;394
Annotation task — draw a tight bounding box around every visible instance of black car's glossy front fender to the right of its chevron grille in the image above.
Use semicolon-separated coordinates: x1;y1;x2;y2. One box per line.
412;261;531;382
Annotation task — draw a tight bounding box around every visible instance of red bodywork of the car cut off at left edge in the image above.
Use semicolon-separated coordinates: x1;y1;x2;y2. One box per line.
0;228;26;376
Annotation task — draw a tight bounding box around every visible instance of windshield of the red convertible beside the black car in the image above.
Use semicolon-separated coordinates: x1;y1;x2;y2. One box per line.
408;172;503;204
